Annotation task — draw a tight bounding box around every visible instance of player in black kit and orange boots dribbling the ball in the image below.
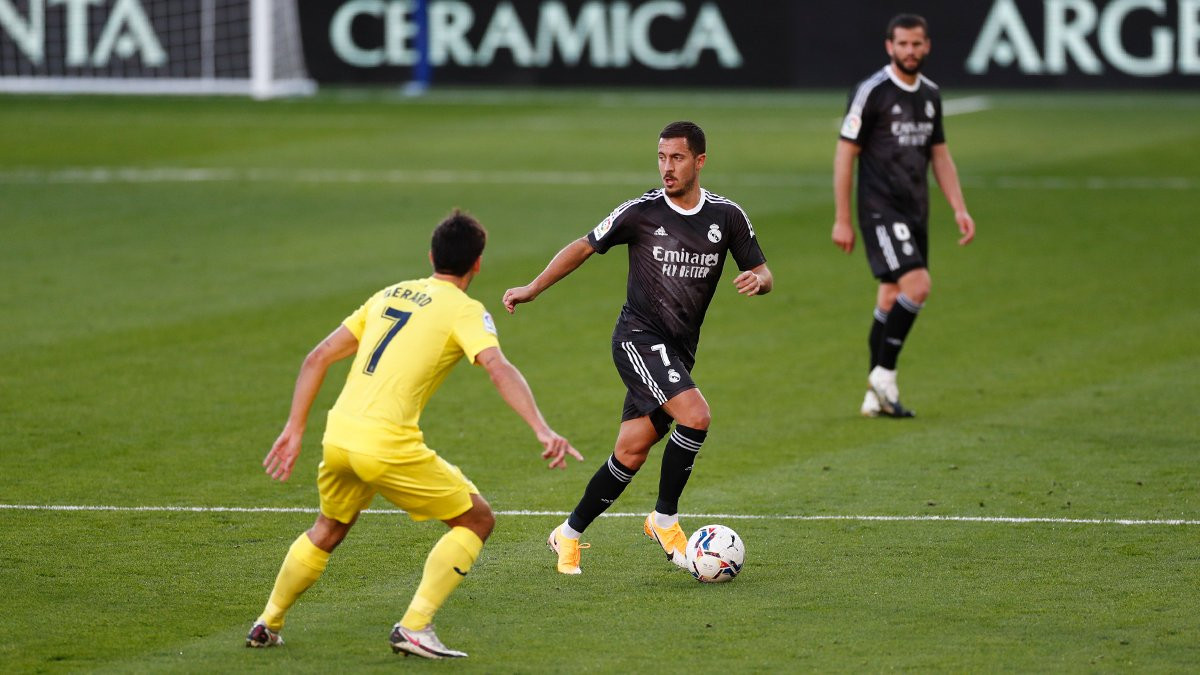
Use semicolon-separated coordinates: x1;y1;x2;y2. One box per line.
504;121;773;574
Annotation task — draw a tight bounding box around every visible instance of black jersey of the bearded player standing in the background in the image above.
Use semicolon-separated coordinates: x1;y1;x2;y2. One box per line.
841;66;946;225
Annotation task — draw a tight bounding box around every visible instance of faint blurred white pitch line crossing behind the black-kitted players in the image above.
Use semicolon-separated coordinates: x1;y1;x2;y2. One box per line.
0;167;1200;191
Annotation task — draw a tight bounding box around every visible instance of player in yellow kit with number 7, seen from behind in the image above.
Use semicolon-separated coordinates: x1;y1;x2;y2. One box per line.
246;210;583;658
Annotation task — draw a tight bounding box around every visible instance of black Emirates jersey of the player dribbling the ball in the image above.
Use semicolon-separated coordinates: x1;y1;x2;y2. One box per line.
588;189;767;363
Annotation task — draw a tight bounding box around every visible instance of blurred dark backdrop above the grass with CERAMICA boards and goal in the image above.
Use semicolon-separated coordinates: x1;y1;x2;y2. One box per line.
0;0;1200;96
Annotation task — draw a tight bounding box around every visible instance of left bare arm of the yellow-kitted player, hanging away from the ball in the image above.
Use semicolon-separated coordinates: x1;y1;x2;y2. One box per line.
263;325;359;480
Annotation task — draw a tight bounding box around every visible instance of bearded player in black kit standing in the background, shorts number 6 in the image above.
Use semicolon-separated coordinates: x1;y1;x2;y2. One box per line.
833;14;974;417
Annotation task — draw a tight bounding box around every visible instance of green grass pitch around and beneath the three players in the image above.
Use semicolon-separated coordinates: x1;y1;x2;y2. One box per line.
0;91;1200;673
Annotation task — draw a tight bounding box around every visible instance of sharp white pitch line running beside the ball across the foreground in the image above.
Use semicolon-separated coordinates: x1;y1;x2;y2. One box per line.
0;504;1200;525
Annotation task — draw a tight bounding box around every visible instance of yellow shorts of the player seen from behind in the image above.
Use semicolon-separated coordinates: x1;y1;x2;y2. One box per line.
317;444;479;522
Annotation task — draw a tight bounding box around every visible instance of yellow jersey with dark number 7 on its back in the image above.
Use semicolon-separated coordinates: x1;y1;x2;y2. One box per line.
325;276;499;461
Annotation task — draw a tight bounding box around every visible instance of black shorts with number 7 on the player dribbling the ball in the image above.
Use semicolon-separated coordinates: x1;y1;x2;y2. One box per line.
612;333;696;426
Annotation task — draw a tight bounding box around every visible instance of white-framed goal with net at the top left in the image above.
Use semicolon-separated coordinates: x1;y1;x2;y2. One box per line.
0;0;317;98
